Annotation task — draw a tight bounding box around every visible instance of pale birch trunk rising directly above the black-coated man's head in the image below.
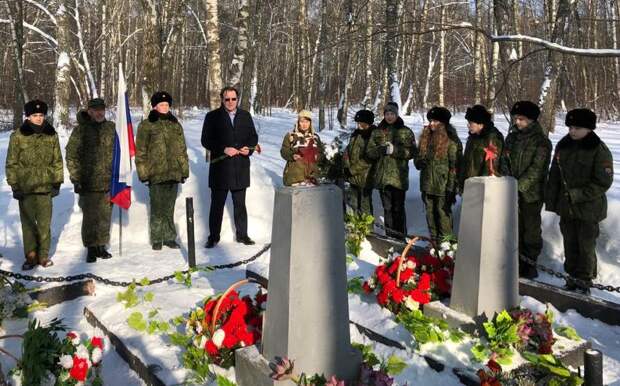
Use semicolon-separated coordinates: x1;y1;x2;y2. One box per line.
205;0;222;110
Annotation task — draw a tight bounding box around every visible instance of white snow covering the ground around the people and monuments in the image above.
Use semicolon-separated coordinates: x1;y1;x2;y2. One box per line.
0;109;620;386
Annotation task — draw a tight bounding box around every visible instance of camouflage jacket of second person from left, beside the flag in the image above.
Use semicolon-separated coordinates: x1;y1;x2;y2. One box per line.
65;111;116;192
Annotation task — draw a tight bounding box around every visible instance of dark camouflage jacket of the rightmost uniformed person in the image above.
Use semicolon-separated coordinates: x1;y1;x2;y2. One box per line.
545;132;614;222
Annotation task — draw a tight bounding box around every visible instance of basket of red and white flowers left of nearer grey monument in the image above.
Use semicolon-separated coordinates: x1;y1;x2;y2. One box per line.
186;290;267;368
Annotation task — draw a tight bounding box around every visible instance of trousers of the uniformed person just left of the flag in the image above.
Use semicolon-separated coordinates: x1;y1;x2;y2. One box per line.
78;192;112;247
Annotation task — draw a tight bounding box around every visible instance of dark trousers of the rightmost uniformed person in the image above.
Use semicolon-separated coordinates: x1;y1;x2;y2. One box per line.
560;217;599;280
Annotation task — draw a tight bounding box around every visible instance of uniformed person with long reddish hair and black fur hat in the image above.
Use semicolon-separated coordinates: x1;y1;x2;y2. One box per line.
414;107;459;244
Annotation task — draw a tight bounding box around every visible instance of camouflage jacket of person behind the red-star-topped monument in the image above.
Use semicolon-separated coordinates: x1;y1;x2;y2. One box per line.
459;123;504;191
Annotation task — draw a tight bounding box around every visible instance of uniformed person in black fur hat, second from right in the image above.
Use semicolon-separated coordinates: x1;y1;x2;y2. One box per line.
502;101;552;279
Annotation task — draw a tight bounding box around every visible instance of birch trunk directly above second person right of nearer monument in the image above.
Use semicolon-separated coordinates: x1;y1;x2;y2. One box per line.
385;0;402;107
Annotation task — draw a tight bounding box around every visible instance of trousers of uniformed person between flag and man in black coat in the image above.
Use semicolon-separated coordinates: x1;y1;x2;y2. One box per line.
149;182;179;243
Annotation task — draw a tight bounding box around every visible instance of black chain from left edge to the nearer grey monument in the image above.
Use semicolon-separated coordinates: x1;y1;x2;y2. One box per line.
0;243;271;287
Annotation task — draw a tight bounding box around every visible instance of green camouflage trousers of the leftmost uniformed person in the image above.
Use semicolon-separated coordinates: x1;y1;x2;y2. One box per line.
19;194;52;259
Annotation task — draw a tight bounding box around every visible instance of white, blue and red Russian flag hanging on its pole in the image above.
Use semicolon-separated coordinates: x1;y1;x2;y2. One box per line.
110;64;136;209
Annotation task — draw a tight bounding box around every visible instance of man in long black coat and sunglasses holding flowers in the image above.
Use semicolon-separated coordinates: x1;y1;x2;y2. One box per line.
201;87;258;248
